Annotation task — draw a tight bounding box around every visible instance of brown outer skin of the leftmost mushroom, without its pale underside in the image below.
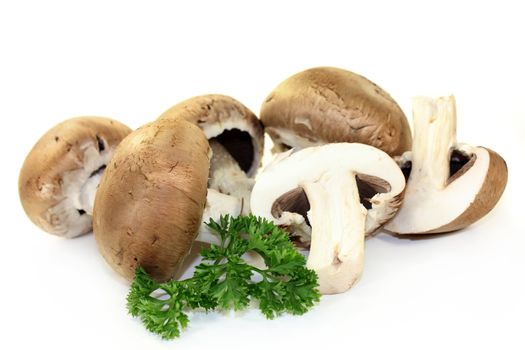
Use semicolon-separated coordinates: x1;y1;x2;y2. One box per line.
18;117;131;236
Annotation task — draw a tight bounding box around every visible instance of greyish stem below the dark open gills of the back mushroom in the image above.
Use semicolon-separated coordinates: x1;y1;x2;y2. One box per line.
208;140;255;214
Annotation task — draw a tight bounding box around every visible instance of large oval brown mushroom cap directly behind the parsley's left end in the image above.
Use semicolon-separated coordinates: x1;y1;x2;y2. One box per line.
93;119;211;281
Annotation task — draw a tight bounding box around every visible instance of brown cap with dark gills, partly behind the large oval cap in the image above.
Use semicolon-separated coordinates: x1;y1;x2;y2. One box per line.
159;95;264;176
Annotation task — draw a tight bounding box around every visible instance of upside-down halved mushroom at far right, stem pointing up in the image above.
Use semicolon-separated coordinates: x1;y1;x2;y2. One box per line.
385;96;507;234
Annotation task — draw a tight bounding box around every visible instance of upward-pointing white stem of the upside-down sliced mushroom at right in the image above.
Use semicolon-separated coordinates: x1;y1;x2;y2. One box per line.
408;96;456;189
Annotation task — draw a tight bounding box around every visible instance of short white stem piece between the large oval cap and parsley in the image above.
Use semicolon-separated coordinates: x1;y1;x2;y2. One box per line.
195;189;244;244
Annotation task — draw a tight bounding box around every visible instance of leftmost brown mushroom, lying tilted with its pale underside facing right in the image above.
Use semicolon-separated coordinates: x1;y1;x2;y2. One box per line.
18;117;131;238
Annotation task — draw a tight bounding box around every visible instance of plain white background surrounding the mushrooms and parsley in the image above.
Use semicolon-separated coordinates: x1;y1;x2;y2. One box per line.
0;0;525;350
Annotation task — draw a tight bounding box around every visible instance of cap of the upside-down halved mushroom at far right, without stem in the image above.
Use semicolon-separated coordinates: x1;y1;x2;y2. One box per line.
385;144;508;234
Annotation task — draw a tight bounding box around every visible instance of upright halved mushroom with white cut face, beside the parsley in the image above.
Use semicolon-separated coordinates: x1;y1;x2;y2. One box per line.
251;143;405;294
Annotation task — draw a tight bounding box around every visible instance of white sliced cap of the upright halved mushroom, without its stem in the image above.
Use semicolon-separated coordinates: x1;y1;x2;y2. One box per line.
251;143;405;234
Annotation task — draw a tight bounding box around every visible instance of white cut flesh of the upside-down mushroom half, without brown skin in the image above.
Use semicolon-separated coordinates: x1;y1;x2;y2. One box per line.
385;96;490;234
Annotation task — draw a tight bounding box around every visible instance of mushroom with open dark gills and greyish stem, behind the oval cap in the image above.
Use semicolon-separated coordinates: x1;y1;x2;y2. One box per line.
159;95;264;213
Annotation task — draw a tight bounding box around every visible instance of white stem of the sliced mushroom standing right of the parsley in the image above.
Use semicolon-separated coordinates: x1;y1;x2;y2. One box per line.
301;171;367;294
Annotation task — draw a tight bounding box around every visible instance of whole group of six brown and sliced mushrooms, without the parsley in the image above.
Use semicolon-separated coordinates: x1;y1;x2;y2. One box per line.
19;67;507;294
